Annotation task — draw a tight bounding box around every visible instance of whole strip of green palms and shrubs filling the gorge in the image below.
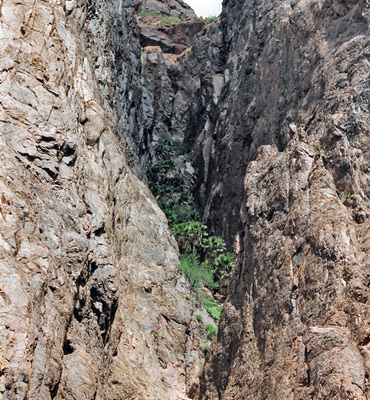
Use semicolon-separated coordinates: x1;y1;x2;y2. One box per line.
148;132;234;328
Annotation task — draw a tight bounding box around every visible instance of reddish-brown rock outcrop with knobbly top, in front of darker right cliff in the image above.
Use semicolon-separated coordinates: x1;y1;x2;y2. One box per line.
200;135;369;399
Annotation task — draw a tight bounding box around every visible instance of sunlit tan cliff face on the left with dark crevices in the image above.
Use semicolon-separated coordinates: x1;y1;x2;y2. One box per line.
0;0;200;400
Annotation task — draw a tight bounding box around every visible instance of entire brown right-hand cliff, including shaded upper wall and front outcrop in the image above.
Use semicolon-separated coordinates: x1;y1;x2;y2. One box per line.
198;0;370;400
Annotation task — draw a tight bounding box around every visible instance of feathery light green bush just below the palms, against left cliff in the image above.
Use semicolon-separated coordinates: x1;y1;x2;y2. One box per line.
178;253;214;289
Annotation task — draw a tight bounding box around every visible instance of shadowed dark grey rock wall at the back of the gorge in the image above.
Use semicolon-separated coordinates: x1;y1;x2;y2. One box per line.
141;17;223;206
